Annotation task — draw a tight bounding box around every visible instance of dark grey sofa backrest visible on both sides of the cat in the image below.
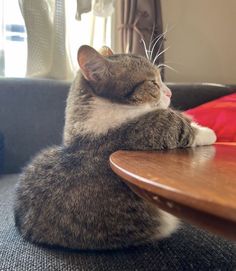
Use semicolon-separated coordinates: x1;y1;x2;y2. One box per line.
0;78;235;173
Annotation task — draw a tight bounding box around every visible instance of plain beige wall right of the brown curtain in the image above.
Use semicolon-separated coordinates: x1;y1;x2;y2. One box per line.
162;0;236;84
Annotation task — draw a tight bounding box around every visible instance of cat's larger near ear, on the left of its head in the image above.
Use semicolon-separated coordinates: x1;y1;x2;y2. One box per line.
77;45;108;81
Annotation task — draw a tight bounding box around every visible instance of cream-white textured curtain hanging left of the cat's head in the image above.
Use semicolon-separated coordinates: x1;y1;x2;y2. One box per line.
19;0;73;80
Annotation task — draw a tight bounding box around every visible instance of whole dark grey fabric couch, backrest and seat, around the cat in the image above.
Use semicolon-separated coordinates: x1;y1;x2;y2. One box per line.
0;79;236;271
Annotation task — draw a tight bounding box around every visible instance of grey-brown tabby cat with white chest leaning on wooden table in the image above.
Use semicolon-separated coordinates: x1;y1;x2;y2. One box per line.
14;45;216;250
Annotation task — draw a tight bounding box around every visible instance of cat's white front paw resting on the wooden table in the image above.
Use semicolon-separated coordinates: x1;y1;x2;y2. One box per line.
191;123;217;147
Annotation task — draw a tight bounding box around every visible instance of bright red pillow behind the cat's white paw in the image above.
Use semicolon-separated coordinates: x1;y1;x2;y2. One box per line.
185;93;236;142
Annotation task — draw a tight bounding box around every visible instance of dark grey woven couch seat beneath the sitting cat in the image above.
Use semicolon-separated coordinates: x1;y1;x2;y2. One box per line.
0;175;236;271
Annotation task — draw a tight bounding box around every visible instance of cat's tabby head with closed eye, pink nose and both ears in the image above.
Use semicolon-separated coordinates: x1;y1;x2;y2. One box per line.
77;45;171;108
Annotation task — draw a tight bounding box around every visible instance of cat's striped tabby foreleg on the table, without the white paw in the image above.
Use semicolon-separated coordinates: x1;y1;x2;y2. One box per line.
121;110;197;150
